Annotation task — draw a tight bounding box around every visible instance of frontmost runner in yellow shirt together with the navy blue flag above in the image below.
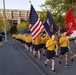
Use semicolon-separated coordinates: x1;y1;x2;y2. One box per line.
44;11;58;73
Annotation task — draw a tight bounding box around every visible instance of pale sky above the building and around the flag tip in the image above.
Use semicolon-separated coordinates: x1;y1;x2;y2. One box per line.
0;0;46;11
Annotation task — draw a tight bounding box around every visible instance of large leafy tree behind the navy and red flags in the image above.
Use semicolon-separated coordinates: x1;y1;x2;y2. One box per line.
41;0;76;28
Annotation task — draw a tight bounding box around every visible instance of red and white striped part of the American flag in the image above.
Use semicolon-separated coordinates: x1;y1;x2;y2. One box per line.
29;19;44;40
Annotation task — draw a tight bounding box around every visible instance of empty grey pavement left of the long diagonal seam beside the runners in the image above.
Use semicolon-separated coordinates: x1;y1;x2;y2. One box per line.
0;38;41;75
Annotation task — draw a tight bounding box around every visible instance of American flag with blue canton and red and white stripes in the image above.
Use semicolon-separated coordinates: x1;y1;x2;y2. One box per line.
29;4;44;40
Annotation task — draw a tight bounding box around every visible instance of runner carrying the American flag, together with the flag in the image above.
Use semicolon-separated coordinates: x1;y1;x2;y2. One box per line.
29;4;44;60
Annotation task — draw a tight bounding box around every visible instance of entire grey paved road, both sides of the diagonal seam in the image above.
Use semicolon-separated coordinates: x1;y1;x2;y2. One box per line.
0;38;76;75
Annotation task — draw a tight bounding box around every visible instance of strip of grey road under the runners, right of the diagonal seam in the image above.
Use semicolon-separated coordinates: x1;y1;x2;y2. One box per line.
17;41;76;75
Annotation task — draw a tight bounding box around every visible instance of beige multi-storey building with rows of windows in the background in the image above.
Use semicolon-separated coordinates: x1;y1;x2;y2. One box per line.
0;9;40;25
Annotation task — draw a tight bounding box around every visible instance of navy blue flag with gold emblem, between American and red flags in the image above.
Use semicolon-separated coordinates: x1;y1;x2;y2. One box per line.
44;11;58;37
